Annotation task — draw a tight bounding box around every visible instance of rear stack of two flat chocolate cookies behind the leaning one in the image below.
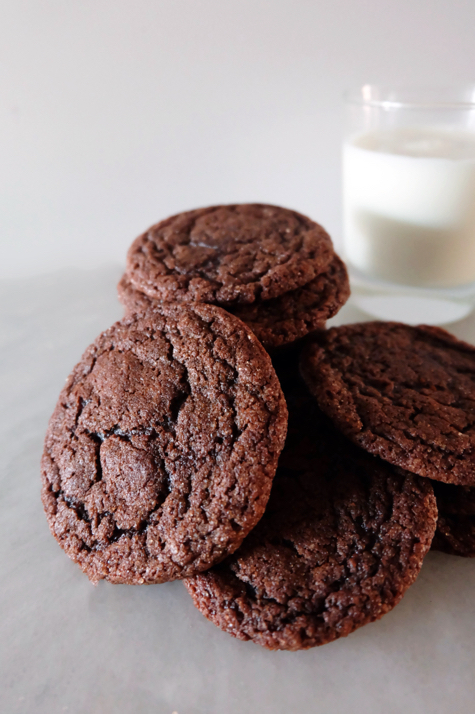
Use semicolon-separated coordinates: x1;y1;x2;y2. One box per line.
118;204;350;350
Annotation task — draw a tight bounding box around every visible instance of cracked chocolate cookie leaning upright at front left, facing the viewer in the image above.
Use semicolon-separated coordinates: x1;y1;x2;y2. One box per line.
42;304;287;583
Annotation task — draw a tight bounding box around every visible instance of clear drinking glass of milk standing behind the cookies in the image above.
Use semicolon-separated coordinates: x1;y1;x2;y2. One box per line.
343;85;475;324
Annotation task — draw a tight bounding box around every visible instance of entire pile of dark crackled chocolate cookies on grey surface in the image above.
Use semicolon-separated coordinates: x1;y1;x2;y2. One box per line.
42;204;475;650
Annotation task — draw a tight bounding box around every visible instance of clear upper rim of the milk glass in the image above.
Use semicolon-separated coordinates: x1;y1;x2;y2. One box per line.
343;83;475;110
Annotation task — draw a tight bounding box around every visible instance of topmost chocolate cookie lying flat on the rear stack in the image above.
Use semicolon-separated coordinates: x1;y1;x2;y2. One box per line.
127;204;333;307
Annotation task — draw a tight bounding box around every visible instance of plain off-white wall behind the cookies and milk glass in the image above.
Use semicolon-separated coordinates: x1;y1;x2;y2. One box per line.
0;0;475;277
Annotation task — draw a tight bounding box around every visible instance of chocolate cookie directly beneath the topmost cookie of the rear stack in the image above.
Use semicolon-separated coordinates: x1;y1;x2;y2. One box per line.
117;255;350;349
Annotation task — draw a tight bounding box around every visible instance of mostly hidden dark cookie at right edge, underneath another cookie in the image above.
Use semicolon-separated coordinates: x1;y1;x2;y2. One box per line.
432;481;475;558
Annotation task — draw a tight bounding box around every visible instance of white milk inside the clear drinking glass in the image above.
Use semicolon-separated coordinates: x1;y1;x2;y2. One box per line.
343;127;475;287
